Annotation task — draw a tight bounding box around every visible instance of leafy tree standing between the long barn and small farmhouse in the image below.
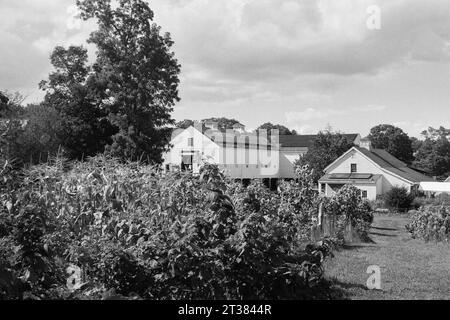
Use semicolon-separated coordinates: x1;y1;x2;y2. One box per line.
296;131;353;182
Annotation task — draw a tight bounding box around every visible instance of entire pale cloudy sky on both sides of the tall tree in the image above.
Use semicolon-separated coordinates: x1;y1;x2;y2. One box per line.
0;0;450;136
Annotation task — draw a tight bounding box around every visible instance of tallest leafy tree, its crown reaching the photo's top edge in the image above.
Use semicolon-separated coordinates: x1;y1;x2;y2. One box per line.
77;0;180;162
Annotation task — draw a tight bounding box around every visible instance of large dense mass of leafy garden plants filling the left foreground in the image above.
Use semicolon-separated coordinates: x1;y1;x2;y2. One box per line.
0;156;332;299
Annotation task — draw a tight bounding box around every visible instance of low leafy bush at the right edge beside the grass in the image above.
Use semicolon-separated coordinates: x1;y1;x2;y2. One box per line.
406;206;450;241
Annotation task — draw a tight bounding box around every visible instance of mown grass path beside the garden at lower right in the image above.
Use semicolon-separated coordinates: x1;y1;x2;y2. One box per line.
325;215;450;300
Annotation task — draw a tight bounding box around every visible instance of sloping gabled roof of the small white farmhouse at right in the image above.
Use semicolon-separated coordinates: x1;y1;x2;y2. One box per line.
325;147;434;183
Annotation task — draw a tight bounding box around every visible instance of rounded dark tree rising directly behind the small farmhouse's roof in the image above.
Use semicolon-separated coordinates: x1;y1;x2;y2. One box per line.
369;124;414;163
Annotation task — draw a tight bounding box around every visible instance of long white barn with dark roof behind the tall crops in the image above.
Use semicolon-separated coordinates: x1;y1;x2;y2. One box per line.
163;122;361;179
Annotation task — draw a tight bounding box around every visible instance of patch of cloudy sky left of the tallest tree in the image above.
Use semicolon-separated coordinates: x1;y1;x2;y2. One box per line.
0;0;92;102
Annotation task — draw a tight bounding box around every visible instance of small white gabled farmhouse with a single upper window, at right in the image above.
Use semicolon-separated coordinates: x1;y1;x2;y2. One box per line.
319;139;433;200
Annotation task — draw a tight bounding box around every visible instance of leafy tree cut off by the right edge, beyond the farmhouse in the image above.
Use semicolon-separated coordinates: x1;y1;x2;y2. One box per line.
414;127;450;179
